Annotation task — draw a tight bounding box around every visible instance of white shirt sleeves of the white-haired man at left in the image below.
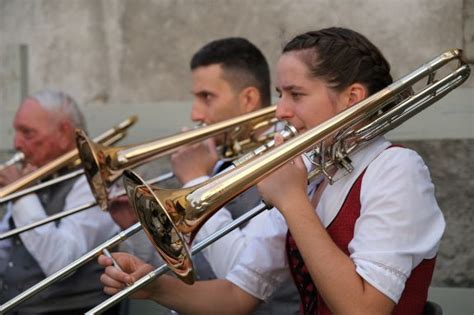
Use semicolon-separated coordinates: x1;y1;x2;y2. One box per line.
0;176;119;276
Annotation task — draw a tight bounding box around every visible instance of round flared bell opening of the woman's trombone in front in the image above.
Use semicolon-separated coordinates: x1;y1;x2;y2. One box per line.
123;170;195;284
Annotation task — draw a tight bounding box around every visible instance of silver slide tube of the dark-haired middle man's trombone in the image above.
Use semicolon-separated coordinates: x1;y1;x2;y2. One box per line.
0;170;174;241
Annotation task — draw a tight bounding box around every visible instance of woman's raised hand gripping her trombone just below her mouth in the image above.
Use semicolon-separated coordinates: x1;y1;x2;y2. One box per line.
257;135;308;215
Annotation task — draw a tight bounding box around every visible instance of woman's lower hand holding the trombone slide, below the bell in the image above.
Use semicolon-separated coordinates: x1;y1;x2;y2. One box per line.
98;253;154;299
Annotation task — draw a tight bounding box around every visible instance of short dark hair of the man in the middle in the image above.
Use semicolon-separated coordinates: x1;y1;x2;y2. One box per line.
190;37;270;106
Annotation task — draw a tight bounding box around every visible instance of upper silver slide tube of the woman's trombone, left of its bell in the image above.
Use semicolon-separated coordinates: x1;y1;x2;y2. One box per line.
0;223;142;314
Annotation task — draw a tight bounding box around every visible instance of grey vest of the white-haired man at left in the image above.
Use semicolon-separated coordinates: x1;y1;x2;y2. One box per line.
0;180;106;314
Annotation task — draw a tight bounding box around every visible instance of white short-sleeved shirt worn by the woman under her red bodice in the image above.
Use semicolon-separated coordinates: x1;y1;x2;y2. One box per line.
225;138;445;303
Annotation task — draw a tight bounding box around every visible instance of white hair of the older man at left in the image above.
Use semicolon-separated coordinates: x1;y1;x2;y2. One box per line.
29;90;86;130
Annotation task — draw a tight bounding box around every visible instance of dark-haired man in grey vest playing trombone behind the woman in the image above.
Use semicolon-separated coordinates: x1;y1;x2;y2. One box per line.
109;37;299;314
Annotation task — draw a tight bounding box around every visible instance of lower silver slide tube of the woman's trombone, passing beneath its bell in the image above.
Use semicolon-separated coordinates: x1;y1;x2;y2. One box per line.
85;202;269;315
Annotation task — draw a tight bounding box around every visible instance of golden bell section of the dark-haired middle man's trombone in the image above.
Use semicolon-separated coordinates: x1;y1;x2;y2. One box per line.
77;106;276;209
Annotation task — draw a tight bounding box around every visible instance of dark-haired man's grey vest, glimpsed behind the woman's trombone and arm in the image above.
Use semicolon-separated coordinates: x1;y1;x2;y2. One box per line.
193;187;300;315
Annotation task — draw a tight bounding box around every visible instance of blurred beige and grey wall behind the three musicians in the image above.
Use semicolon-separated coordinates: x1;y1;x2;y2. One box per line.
0;0;474;312
